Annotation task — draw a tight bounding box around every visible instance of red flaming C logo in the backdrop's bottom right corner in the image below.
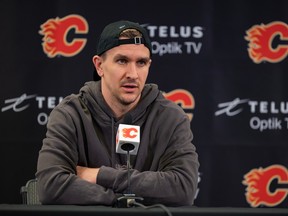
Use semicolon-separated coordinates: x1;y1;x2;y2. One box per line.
242;165;288;207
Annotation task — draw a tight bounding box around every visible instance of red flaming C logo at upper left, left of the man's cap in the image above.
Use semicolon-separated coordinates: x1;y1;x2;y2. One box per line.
39;14;88;58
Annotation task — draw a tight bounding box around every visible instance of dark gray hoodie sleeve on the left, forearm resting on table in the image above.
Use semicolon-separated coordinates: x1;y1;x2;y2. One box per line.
35;100;115;205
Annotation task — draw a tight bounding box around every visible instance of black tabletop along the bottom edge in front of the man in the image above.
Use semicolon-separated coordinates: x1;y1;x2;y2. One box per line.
0;204;288;216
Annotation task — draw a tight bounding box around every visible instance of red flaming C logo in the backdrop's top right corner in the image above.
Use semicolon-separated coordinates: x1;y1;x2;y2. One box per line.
245;22;288;64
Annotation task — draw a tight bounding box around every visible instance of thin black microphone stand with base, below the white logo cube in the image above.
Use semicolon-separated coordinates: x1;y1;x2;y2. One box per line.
117;143;143;208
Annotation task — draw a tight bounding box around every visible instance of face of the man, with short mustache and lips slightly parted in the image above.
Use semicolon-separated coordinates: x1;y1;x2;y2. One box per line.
97;44;151;107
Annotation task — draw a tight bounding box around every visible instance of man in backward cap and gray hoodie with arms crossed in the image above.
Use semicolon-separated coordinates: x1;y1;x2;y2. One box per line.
36;21;199;206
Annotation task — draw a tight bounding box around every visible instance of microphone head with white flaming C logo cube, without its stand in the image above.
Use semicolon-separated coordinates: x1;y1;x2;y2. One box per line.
116;113;140;155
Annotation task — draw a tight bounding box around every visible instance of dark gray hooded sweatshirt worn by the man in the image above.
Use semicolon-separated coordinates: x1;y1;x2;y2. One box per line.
36;81;199;206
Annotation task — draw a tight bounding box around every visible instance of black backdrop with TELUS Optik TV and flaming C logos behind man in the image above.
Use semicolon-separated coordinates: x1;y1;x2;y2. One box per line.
0;0;288;208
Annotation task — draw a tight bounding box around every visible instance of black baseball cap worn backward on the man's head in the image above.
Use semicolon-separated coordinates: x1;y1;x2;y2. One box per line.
97;20;152;55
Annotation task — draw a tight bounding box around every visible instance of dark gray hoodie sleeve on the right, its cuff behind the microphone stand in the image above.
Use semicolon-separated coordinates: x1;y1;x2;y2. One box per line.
97;105;199;206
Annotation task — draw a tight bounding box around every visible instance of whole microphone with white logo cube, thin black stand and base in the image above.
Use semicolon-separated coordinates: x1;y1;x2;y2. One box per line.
116;113;143;208
